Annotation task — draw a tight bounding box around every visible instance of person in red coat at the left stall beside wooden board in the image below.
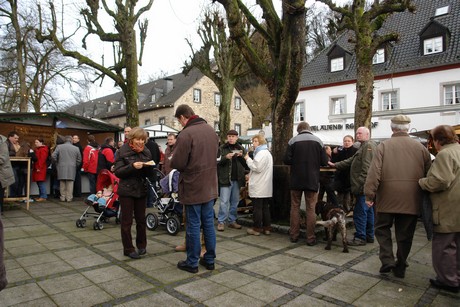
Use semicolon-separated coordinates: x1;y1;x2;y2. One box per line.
32;138;49;201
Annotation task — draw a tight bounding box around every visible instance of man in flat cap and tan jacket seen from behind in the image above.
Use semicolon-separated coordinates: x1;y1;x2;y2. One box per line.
364;114;431;278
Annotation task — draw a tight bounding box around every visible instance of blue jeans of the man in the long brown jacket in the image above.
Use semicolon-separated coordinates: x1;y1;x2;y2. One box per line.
185;200;216;268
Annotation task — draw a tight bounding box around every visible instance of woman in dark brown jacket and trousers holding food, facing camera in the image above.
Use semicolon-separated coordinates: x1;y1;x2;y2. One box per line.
115;127;153;259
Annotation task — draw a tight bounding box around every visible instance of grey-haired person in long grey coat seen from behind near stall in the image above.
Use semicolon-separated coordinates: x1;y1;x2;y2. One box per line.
52;135;81;201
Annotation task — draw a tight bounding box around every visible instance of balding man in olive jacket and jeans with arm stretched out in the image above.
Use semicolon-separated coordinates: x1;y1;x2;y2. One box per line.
329;127;377;246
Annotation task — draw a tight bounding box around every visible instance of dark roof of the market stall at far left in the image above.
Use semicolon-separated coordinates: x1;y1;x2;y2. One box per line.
0;112;123;132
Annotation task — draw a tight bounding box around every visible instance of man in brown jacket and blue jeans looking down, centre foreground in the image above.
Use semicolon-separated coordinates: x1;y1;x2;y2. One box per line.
171;104;219;273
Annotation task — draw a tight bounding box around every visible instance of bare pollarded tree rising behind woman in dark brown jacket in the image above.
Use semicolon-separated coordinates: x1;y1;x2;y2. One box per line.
36;0;153;126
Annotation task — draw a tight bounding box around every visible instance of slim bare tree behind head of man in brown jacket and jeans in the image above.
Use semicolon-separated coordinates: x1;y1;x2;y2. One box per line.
184;10;249;143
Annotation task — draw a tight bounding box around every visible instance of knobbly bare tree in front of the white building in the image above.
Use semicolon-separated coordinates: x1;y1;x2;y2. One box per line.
317;0;415;130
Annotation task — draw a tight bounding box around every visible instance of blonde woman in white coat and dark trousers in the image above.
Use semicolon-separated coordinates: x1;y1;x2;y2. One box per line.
244;134;273;236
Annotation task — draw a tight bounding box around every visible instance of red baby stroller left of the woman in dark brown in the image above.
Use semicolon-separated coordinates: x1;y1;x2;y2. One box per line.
76;169;120;230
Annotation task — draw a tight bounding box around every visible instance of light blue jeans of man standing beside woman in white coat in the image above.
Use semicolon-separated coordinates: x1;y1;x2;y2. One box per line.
217;181;240;224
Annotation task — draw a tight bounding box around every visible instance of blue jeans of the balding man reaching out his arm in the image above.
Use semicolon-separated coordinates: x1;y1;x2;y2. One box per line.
353;195;374;241
